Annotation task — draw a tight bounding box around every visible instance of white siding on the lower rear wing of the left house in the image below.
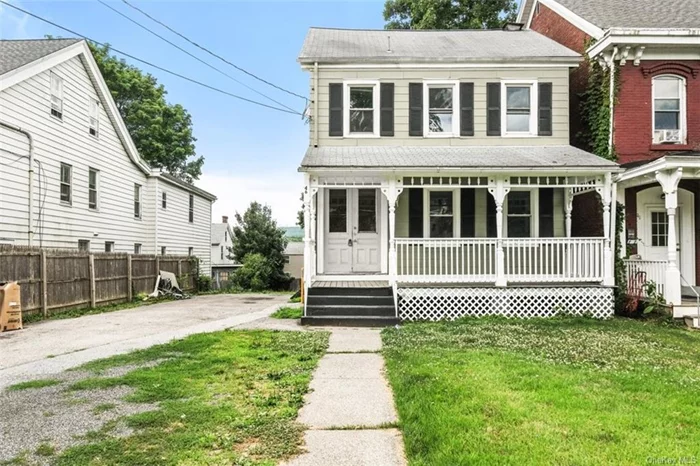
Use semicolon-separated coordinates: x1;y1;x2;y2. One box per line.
155;179;212;275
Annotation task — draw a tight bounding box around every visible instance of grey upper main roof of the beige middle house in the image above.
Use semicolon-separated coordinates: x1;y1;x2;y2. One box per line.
299;28;580;63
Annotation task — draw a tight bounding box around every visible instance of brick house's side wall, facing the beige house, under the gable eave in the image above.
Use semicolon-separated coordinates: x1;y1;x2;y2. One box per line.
524;4;590;148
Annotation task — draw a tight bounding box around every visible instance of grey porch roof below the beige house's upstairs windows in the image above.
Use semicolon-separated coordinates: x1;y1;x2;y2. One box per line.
300;145;619;171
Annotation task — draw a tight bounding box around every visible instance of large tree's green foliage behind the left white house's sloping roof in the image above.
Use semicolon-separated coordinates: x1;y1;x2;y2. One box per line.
89;44;204;182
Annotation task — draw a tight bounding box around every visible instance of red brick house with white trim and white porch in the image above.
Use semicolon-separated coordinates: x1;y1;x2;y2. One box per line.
518;0;700;316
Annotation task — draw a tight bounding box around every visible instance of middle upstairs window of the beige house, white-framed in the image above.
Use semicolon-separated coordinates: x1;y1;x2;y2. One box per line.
423;81;459;137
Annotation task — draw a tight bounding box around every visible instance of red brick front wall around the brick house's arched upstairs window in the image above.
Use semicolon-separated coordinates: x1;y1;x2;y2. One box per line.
614;60;700;163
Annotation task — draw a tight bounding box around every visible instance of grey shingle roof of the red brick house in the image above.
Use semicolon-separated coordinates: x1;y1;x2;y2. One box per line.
556;0;700;29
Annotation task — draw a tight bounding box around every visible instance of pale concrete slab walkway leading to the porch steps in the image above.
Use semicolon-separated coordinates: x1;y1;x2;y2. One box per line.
286;328;406;466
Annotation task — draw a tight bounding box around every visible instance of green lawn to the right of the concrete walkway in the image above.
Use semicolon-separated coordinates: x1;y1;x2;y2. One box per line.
383;319;700;466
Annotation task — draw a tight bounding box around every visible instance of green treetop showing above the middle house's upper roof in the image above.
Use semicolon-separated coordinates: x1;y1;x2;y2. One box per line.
384;0;518;29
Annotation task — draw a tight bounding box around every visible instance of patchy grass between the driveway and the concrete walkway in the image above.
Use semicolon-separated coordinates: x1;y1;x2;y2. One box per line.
54;330;328;466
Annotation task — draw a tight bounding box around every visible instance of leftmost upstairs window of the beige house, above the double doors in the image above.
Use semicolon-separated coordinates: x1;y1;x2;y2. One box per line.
343;81;379;137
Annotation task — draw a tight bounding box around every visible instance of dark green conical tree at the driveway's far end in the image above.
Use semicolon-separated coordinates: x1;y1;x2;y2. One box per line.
231;202;289;288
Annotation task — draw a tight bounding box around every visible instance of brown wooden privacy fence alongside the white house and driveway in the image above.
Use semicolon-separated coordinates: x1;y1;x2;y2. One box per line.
0;246;197;316
